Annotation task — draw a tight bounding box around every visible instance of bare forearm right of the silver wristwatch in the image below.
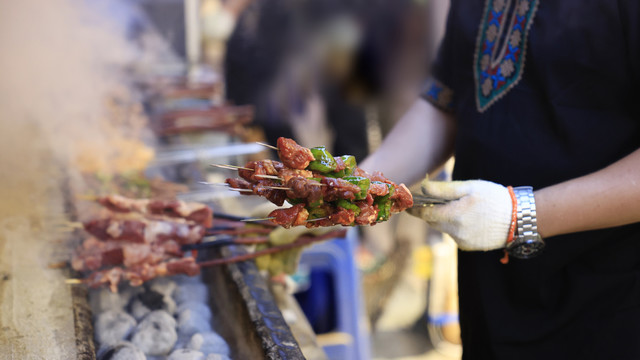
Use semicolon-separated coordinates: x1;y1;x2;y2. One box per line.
535;149;640;238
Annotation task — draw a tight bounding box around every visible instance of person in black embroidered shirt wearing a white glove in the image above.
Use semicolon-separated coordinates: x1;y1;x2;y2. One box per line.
362;0;640;360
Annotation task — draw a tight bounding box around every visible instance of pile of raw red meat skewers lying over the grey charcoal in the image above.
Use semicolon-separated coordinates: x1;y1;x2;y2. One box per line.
68;194;298;291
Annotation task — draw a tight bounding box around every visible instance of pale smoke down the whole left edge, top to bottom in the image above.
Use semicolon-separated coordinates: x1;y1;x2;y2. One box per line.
0;0;182;359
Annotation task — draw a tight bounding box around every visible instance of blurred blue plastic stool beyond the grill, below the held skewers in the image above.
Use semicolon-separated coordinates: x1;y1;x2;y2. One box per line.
297;228;370;360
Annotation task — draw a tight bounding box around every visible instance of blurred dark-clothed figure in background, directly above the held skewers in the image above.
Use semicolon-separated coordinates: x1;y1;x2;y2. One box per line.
224;0;368;158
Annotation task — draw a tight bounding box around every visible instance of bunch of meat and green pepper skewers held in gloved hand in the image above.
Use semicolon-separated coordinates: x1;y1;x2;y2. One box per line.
221;138;413;227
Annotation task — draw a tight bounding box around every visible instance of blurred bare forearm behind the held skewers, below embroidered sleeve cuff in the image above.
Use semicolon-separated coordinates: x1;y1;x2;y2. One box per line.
360;99;455;184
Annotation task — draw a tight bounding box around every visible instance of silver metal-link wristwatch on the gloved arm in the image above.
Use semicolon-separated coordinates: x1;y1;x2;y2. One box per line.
507;186;544;259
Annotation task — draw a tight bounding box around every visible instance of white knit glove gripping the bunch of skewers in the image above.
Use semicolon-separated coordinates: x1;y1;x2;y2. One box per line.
413;179;513;251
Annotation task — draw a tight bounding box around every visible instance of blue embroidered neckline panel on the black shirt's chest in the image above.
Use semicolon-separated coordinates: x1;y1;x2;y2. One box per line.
474;0;539;112
